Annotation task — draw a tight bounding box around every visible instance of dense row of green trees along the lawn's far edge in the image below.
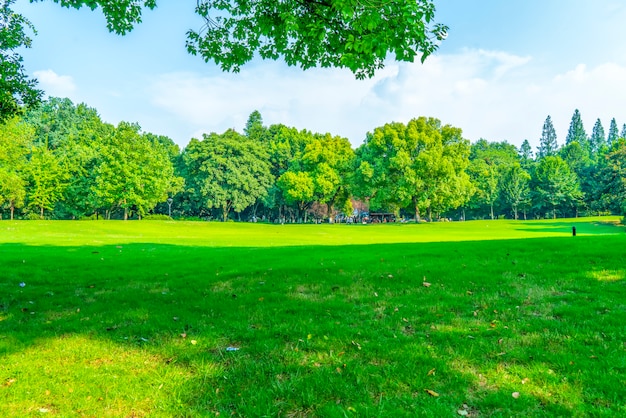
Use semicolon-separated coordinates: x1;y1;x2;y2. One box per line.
0;98;626;222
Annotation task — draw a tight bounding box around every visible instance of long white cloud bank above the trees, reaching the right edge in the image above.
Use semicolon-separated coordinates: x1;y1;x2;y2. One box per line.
148;50;626;150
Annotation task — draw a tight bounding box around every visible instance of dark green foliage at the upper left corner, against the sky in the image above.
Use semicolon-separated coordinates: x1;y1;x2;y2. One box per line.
0;0;43;123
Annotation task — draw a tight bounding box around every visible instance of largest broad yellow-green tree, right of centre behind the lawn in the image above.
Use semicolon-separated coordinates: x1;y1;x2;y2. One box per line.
354;117;471;221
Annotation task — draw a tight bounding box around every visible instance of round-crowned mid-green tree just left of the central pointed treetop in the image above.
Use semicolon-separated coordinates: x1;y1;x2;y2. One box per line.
183;130;272;221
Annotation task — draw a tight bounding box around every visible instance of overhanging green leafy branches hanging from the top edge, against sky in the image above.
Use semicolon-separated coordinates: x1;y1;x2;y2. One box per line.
33;0;448;78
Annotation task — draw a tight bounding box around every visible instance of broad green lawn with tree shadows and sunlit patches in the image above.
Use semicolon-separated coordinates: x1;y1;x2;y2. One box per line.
0;218;626;417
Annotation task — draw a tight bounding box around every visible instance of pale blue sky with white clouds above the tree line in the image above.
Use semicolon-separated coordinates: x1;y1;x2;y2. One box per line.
15;0;626;147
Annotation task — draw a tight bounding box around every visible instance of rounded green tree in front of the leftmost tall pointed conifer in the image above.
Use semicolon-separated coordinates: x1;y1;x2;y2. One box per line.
533;156;582;218
